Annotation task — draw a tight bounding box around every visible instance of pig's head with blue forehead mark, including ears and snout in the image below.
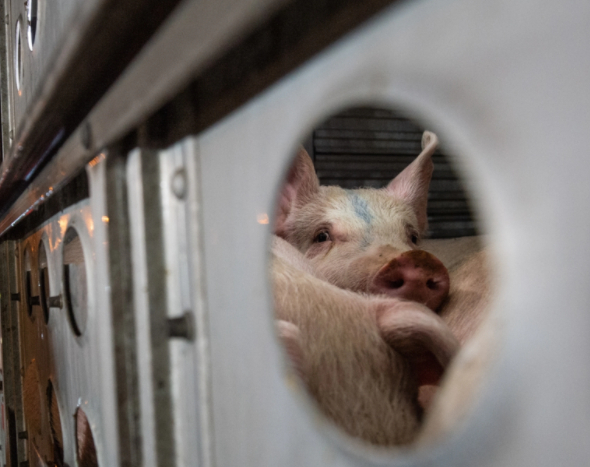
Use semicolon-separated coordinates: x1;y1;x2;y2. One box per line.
275;132;449;310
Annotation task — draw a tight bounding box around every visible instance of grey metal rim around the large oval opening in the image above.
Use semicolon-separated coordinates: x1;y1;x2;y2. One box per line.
266;102;503;465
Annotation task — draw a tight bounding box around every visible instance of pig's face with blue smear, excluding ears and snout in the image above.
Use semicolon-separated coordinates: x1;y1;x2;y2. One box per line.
287;187;419;291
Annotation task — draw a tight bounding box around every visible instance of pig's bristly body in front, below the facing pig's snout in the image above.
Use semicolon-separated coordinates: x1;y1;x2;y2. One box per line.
272;238;458;446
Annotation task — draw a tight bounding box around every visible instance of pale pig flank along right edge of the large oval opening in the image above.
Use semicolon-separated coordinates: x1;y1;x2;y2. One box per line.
416;237;502;445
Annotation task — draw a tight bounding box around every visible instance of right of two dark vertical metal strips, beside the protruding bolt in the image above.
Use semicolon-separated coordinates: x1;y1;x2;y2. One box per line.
141;150;176;467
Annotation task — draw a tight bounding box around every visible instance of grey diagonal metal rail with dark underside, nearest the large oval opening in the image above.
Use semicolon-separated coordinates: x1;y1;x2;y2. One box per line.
0;0;402;236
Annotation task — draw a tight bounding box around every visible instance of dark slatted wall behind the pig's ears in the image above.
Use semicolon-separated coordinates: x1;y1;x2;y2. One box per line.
312;108;476;238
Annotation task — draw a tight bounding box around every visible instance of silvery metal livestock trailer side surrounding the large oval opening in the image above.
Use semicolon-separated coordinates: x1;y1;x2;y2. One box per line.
0;0;590;467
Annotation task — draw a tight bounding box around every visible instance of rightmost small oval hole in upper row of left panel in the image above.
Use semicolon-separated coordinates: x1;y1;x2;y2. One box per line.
63;227;88;336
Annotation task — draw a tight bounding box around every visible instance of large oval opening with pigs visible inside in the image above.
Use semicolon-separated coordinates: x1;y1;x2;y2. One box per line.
271;107;490;447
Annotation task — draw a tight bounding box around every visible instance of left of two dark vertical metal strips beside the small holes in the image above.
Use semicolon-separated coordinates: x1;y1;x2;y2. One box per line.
106;147;142;467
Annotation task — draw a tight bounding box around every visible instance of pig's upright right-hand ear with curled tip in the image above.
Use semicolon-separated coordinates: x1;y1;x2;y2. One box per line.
386;131;438;232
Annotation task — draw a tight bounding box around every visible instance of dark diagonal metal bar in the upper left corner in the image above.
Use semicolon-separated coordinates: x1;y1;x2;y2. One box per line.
0;0;187;218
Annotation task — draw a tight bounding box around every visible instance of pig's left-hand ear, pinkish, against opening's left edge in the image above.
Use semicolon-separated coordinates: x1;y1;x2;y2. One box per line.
275;147;320;237
